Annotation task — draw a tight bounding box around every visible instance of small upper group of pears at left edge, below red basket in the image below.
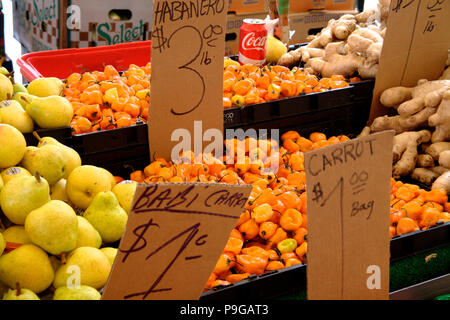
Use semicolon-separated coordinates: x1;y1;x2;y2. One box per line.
0;68;73;133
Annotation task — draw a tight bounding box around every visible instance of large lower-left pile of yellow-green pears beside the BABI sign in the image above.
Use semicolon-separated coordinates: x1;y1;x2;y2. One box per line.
0;124;136;300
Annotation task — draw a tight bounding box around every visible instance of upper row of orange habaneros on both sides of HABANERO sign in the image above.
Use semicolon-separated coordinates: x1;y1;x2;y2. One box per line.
63;58;360;134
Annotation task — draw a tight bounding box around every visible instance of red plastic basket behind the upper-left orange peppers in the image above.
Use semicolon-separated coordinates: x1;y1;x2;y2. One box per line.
17;40;151;82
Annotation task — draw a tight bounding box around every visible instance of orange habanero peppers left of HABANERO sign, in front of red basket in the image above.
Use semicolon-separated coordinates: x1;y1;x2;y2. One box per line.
63;63;151;134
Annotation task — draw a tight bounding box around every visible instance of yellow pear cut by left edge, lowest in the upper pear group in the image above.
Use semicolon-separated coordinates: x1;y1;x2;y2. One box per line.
0;100;34;133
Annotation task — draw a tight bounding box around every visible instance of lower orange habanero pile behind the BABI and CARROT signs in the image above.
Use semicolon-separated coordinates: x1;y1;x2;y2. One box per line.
125;131;450;290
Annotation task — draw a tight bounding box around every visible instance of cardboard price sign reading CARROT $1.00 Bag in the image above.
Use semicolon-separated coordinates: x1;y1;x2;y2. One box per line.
305;131;394;300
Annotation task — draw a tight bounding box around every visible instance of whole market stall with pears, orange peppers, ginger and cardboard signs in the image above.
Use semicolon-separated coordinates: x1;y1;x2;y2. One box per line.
0;0;450;301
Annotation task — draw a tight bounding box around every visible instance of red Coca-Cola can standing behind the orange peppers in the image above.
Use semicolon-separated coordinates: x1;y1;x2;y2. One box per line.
239;19;267;65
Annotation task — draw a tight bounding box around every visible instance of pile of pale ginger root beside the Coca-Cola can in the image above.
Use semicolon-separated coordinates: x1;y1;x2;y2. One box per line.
277;0;390;79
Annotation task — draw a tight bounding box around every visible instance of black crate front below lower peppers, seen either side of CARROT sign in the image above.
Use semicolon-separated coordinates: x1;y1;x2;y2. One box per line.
200;222;450;301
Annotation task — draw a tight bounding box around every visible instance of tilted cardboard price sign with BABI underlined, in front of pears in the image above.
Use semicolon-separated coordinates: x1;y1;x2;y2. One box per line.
102;183;251;300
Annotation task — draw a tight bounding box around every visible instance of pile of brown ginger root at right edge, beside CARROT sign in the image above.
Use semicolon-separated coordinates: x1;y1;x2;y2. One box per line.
360;62;450;193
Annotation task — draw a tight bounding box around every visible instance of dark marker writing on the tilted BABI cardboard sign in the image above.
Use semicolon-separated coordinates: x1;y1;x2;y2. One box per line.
119;184;248;299
